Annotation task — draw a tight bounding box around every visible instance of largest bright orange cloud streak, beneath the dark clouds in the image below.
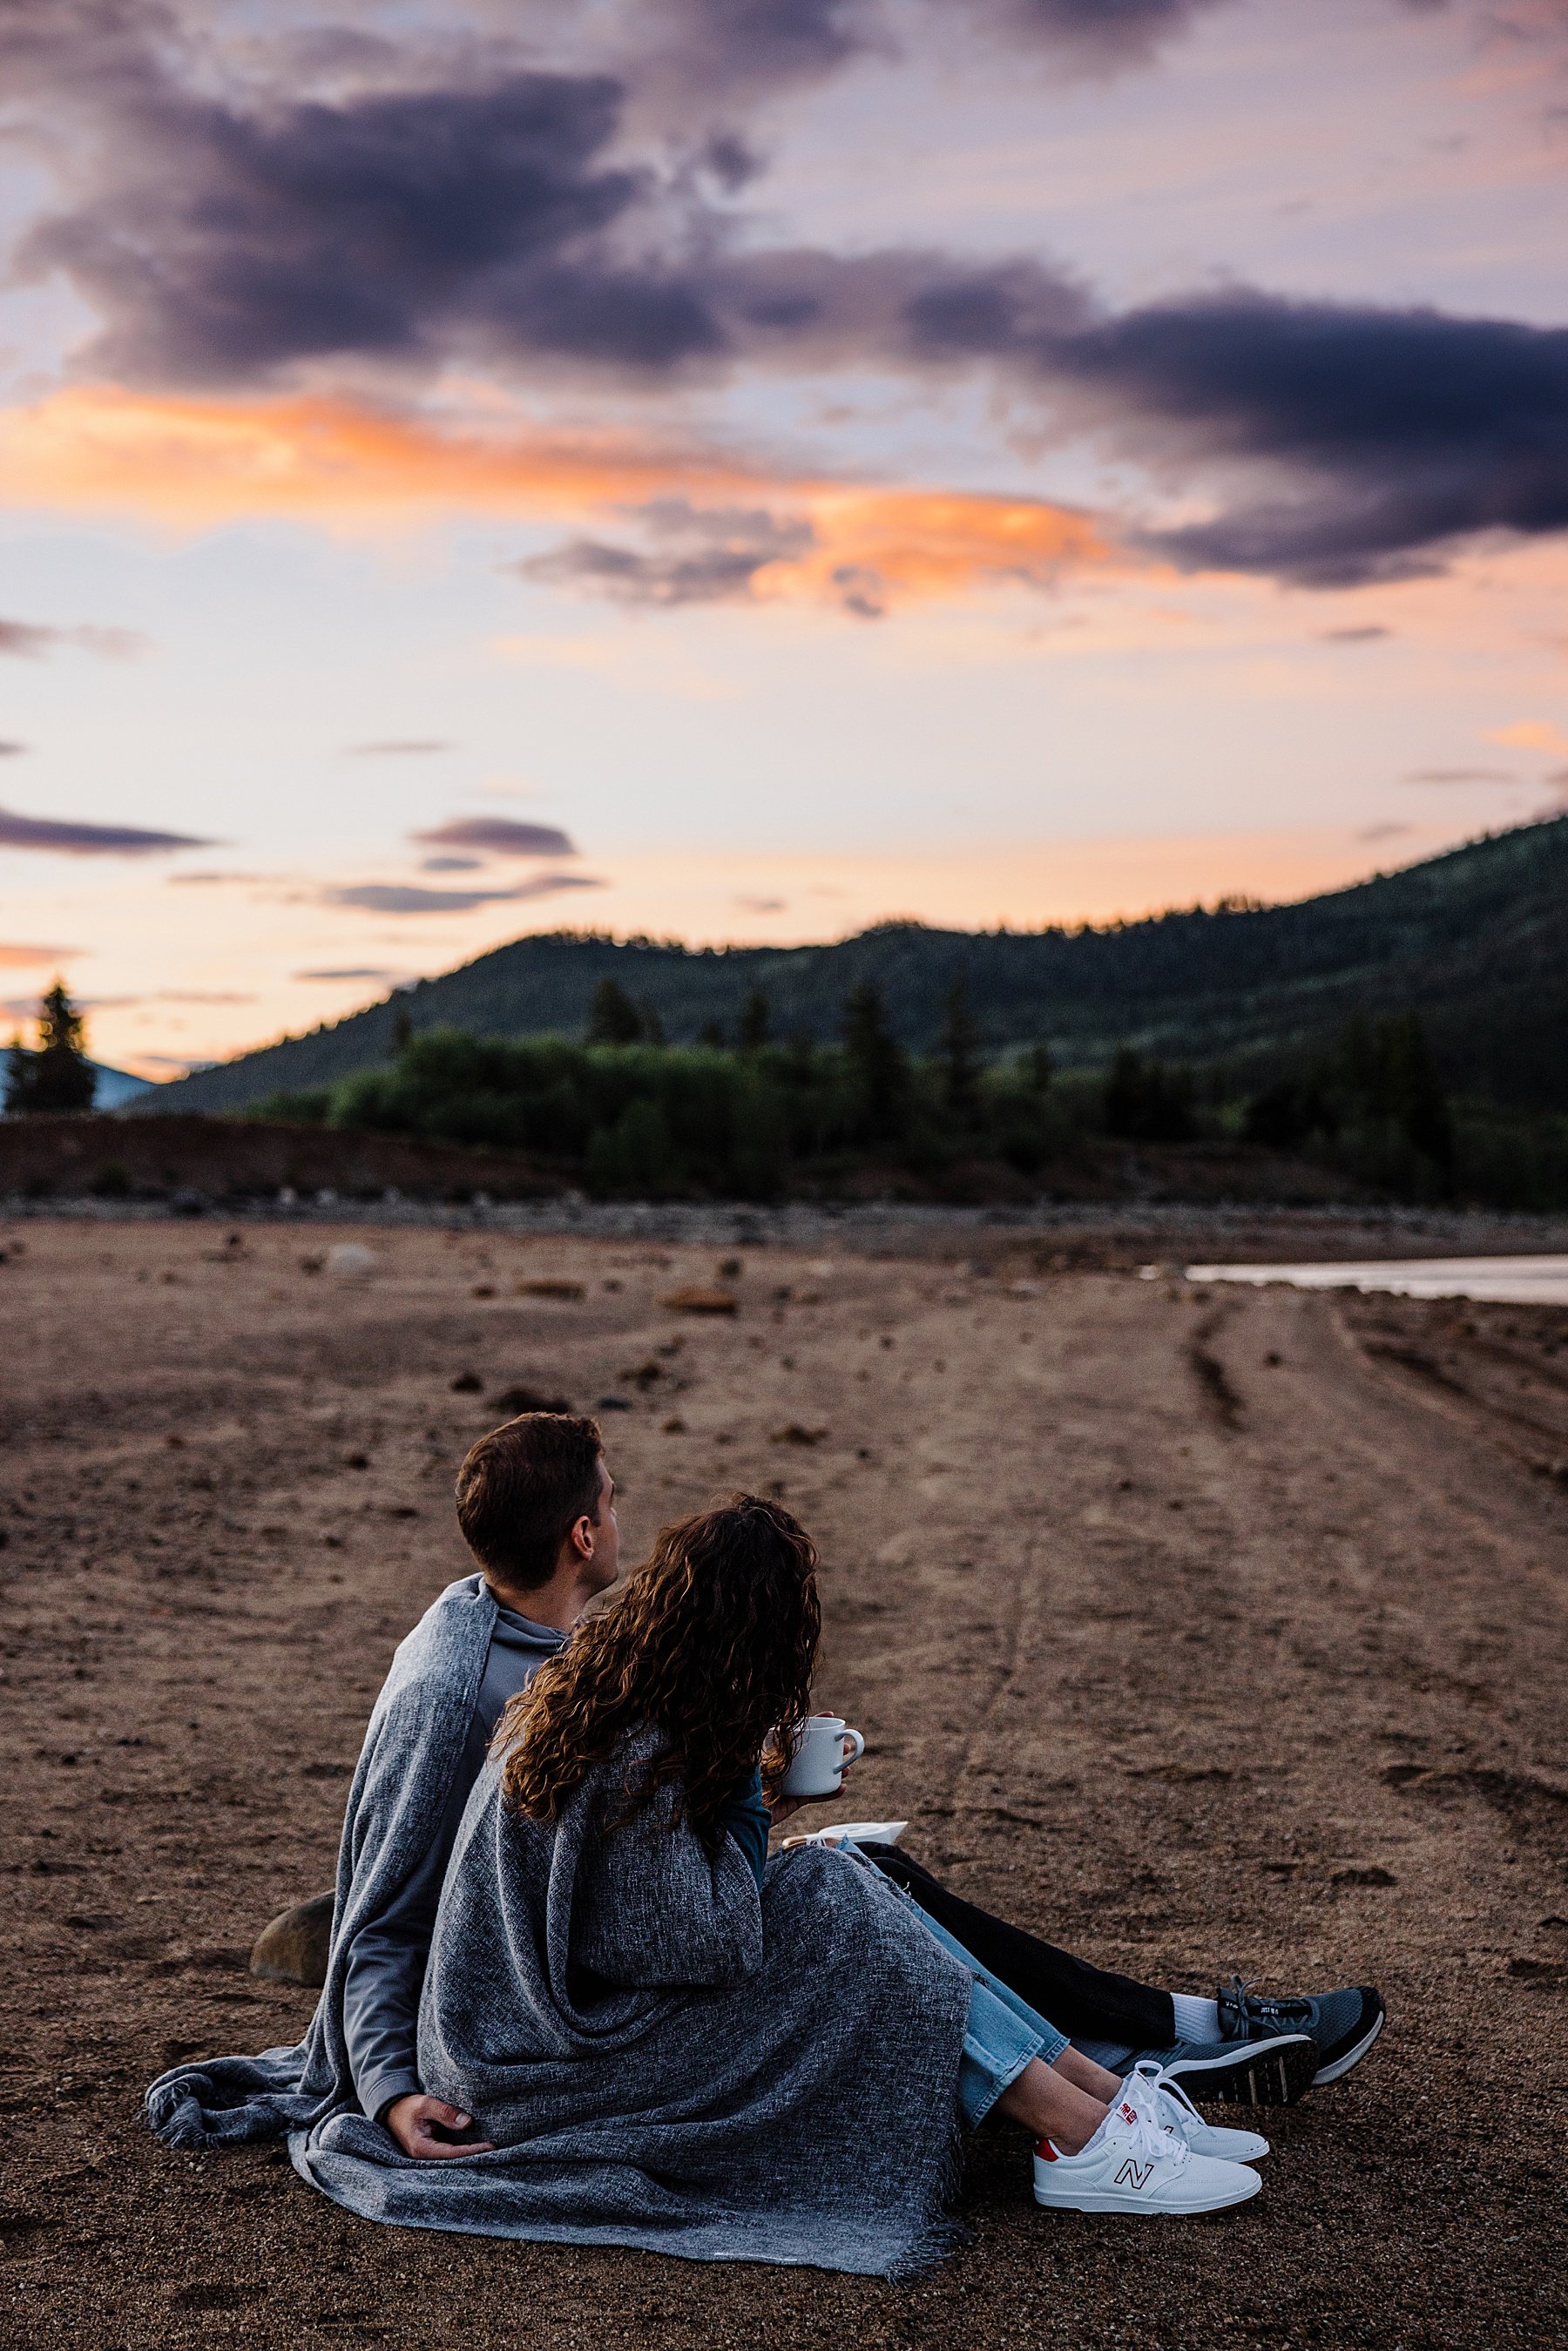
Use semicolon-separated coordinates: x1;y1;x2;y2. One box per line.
0;388;1126;609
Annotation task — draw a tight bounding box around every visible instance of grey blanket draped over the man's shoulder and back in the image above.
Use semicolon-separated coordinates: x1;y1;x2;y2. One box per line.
148;1575;496;2146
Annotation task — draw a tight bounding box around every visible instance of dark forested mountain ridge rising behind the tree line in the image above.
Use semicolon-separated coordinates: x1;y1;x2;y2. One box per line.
134;816;1568;1112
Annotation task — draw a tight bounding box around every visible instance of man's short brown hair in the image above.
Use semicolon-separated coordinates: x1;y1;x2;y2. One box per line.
456;1413;605;1591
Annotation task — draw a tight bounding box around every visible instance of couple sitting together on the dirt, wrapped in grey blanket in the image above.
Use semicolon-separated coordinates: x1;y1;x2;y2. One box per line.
148;1413;1382;2276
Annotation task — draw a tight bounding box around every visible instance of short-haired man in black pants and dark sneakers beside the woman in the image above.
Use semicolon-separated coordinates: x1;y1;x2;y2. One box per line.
148;1413;1382;2160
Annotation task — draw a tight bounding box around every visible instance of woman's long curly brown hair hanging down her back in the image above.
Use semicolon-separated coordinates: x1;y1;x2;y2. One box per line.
491;1493;821;1850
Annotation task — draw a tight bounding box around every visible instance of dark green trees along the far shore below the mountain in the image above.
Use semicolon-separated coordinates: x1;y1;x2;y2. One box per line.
4;971;1568;1208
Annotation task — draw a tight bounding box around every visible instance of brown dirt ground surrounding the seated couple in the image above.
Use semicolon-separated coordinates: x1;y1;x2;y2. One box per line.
0;1218;1568;2351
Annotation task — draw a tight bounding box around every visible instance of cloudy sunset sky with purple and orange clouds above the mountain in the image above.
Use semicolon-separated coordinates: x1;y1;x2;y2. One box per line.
0;0;1568;1074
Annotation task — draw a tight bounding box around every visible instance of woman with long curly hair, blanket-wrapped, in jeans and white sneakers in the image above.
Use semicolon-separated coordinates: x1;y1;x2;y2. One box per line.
296;1497;1255;2276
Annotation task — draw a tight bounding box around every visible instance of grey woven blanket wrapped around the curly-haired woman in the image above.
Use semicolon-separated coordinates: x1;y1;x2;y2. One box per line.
292;1733;971;2276
